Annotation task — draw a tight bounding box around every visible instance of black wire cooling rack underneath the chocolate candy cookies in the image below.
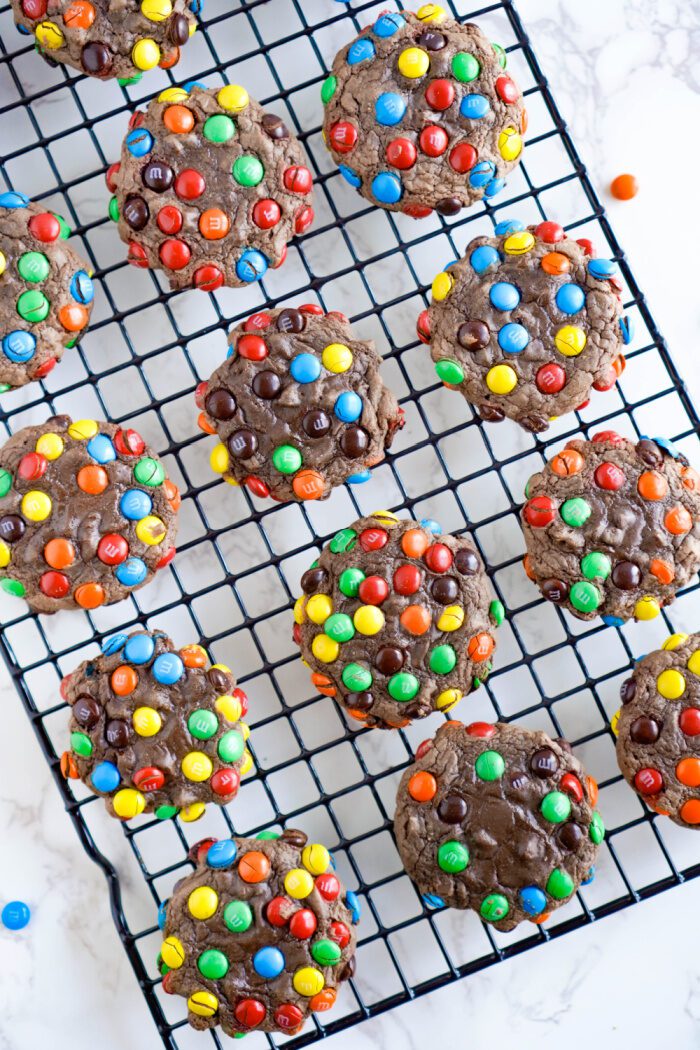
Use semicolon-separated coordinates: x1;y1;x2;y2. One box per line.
0;0;700;1050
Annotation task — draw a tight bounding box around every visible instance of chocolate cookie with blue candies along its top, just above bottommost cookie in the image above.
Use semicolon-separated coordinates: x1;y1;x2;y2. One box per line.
61;631;253;821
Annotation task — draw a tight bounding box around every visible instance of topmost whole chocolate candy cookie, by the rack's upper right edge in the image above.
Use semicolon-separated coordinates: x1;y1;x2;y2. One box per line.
321;3;527;218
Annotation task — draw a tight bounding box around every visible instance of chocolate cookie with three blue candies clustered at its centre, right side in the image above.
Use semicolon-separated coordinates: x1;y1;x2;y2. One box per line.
418;222;631;433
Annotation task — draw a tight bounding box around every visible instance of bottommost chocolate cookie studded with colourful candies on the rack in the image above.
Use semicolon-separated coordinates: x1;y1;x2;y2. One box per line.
158;830;360;1035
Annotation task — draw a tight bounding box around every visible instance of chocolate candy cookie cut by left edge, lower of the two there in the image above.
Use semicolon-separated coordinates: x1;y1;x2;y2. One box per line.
0;416;179;612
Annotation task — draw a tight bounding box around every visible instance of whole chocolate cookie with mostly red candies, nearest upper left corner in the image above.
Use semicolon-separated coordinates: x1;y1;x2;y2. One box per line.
107;84;314;292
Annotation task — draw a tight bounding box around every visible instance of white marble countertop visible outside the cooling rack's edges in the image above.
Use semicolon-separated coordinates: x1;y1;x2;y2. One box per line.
0;0;700;1050
